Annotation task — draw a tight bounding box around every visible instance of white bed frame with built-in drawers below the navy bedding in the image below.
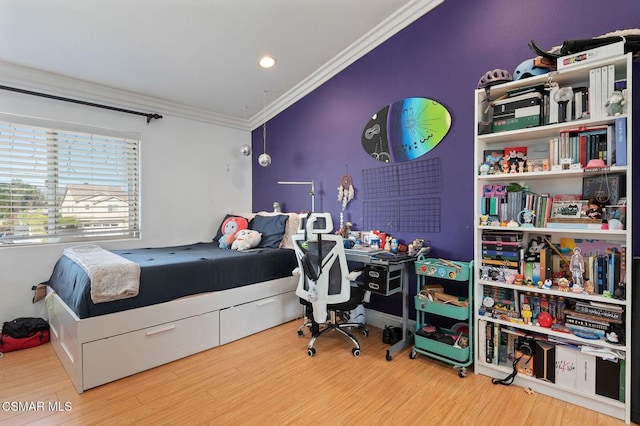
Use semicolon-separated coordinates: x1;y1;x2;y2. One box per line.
47;276;302;393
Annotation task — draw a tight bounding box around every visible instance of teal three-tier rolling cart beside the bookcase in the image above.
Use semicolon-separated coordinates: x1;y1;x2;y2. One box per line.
410;256;473;377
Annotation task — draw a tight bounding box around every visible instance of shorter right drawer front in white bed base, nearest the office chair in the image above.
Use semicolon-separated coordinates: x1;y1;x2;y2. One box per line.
220;291;301;345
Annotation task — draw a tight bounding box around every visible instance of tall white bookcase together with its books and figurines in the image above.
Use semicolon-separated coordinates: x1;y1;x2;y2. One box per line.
472;55;633;423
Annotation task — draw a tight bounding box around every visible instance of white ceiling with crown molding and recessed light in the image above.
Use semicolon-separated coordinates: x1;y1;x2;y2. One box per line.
0;0;444;129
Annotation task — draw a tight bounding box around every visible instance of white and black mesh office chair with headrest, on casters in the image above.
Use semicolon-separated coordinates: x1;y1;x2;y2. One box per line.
292;213;370;356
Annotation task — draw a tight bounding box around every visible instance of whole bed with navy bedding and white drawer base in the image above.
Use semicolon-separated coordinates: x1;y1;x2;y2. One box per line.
46;214;301;393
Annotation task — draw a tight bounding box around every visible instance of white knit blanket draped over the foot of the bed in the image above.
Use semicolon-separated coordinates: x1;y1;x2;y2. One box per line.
63;244;140;303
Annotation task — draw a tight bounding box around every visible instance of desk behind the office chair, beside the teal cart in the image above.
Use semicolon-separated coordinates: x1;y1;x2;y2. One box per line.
344;249;415;361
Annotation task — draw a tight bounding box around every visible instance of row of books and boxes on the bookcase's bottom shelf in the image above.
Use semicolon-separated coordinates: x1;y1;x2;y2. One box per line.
478;321;626;402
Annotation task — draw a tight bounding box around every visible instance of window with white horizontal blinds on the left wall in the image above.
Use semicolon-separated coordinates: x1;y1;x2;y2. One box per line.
0;114;140;246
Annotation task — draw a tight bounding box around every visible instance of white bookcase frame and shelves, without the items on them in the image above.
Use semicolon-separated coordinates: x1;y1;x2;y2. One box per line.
474;54;633;423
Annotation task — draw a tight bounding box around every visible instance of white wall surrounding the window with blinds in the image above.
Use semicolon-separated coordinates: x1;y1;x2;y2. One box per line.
0;85;252;322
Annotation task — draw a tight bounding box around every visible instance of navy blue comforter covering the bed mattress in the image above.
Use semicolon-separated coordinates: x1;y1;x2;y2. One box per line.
47;242;297;318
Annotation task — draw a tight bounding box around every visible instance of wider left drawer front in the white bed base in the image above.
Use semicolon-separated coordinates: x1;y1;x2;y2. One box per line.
82;311;219;389
